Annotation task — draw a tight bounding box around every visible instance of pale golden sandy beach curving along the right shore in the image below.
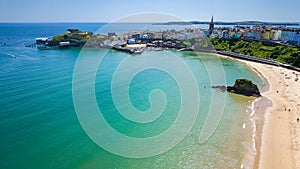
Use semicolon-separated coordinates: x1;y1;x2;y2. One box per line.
217;56;300;169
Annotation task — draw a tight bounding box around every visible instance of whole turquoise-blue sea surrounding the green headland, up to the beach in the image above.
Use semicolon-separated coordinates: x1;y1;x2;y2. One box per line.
0;23;265;169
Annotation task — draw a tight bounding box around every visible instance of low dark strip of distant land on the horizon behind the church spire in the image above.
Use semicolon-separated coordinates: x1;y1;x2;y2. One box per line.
153;21;299;26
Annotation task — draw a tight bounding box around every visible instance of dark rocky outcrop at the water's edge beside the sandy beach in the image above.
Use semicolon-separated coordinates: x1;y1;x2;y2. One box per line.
227;79;260;97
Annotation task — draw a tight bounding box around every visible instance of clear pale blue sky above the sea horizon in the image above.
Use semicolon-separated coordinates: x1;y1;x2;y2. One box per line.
0;0;300;22
